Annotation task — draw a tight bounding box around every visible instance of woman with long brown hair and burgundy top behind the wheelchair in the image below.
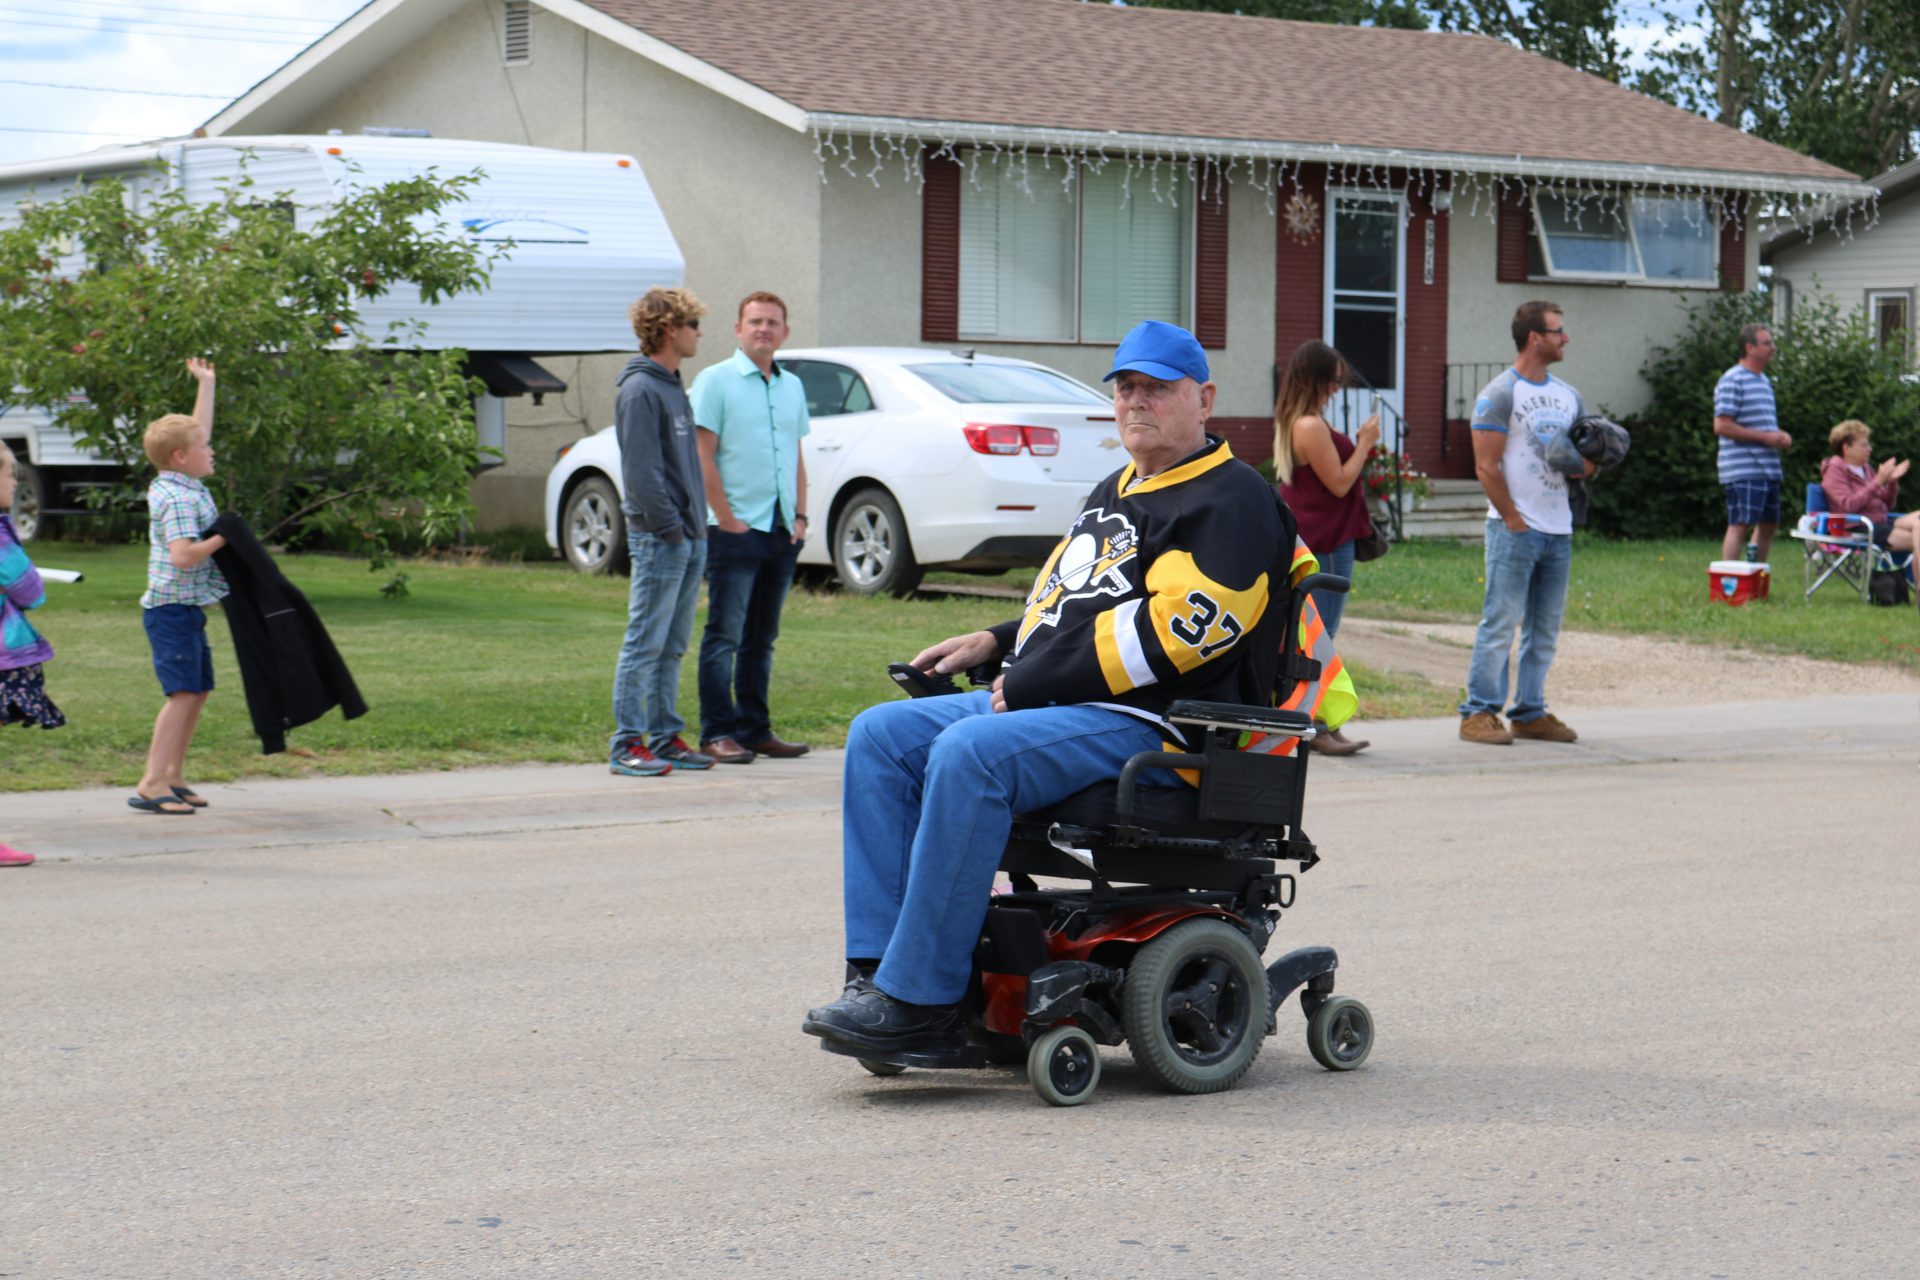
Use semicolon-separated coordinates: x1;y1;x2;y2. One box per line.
1273;342;1380;756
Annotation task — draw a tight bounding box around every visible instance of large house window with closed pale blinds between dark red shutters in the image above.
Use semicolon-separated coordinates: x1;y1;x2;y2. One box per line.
958;157;1194;342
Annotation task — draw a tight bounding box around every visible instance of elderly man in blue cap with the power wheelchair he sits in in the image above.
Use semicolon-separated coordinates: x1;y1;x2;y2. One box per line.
803;320;1373;1105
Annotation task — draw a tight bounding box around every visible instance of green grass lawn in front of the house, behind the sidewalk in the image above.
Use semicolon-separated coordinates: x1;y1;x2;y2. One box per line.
11;539;1920;791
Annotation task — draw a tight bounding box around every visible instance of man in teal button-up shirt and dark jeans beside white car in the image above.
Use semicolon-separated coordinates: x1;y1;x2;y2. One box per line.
689;294;808;764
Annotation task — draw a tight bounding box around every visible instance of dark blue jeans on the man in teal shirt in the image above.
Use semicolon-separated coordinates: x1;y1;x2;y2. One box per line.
701;526;801;747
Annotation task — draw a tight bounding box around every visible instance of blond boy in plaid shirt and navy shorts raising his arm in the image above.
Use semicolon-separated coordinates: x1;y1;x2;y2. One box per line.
127;359;227;814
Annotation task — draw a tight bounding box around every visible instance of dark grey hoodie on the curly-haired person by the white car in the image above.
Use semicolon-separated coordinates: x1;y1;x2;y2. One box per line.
612;355;707;543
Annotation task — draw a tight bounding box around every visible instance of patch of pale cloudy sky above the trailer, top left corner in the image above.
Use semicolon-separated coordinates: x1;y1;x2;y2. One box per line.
0;0;365;163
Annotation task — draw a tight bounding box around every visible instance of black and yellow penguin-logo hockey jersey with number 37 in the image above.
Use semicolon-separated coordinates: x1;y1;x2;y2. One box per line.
993;436;1294;727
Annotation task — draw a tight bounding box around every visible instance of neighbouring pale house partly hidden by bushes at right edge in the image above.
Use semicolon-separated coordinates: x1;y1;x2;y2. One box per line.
1761;159;1920;365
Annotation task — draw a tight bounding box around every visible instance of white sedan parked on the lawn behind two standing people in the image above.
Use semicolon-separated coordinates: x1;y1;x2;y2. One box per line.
547;347;1127;595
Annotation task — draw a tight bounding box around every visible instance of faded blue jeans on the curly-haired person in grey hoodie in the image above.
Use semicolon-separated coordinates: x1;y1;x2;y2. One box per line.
607;530;707;760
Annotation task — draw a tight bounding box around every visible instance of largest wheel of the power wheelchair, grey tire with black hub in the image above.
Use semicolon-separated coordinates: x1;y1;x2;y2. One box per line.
1119;919;1269;1094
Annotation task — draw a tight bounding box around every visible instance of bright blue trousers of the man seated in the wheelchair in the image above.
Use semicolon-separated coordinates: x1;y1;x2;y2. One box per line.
841;691;1179;1004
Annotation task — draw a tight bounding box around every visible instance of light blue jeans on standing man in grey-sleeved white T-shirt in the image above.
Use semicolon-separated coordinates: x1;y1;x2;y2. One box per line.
1459;520;1572;723
